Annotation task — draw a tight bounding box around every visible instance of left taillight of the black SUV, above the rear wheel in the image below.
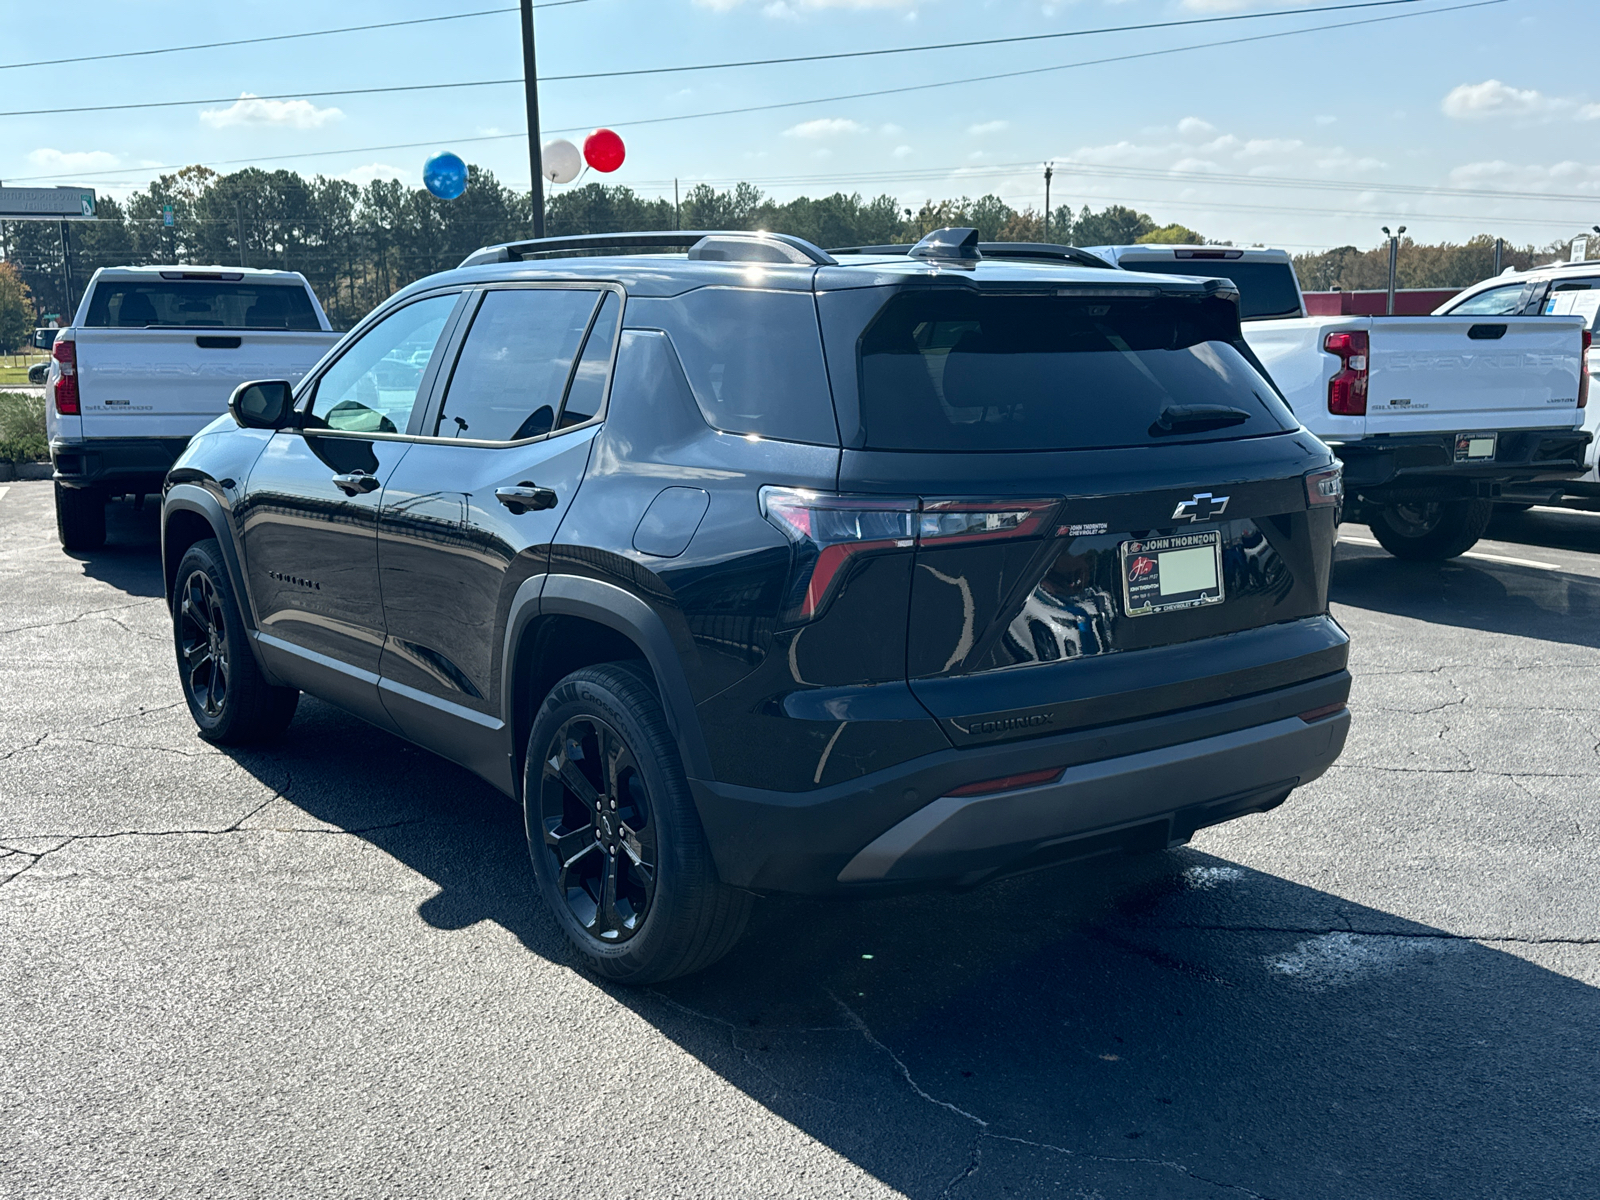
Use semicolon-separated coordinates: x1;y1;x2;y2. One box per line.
760;488;1059;622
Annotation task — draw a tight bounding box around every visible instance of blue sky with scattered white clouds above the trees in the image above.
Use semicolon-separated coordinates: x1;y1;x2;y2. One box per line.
0;0;1600;251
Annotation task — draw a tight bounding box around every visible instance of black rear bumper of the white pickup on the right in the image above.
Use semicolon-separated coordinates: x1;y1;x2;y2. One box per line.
1333;426;1590;504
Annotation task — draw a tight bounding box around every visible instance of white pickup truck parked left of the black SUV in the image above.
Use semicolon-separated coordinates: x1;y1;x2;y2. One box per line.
45;267;339;550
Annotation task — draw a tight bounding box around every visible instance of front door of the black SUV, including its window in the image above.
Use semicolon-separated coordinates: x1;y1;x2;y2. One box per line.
240;293;461;723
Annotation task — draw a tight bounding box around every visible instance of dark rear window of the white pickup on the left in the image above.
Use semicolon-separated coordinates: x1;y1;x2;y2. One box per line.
85;280;322;330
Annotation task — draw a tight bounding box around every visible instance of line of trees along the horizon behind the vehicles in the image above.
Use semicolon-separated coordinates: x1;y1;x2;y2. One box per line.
0;157;1574;340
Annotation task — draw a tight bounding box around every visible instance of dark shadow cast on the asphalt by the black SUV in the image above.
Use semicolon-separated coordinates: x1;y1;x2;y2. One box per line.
219;699;1600;1200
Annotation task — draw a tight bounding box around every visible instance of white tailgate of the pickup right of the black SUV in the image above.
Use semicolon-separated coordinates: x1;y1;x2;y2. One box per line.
1366;317;1582;435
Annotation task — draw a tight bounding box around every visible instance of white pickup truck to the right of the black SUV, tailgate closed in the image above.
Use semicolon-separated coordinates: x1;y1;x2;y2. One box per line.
1088;245;1590;560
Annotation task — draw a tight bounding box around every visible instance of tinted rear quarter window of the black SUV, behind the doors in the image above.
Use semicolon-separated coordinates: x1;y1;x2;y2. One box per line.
629;288;838;446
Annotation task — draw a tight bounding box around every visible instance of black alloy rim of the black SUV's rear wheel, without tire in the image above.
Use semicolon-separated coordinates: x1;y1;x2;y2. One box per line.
539;717;659;944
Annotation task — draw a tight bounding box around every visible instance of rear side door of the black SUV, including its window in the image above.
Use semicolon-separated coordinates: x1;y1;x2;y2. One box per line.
378;286;622;770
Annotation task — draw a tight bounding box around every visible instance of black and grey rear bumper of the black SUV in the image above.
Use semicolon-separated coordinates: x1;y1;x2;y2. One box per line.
690;670;1350;893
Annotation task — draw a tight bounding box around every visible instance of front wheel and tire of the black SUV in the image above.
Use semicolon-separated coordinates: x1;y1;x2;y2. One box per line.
173;538;299;746
